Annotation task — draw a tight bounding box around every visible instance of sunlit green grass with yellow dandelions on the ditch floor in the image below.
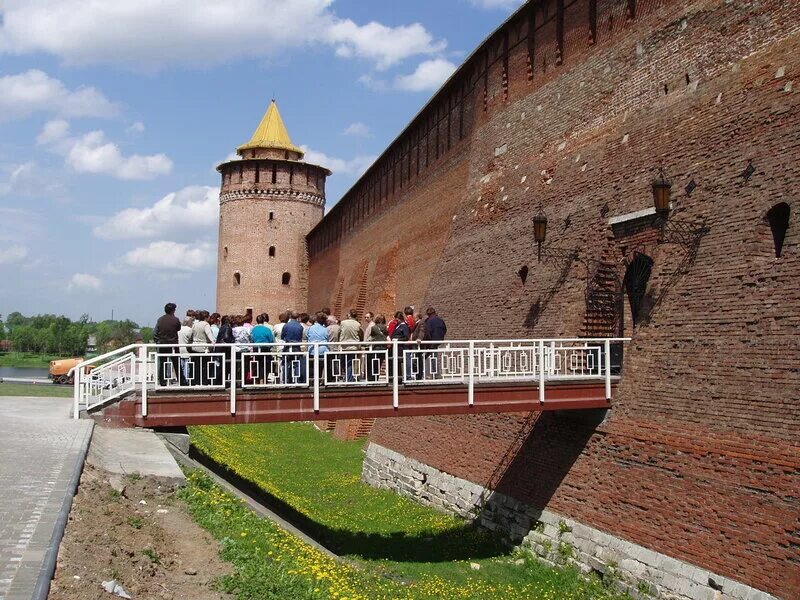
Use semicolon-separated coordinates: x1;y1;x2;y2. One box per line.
191;423;620;600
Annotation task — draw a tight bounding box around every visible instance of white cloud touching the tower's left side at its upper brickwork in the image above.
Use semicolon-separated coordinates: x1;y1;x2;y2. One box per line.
93;185;219;240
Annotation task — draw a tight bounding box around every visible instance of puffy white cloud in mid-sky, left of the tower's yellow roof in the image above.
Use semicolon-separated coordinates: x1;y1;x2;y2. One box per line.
36;120;172;179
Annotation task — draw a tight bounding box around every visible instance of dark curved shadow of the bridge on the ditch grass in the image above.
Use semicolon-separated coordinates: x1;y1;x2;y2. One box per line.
189;446;508;562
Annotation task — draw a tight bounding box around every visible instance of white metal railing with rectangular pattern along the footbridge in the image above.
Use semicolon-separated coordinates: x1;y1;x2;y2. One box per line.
73;338;629;418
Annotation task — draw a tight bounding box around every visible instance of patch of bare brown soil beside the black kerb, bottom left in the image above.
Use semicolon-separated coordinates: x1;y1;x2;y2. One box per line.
48;464;231;600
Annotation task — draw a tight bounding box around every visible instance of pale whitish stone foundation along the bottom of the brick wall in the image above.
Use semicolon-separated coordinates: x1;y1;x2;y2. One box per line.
361;443;777;600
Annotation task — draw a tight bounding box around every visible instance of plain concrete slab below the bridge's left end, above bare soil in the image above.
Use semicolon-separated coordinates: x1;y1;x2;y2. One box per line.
87;427;186;485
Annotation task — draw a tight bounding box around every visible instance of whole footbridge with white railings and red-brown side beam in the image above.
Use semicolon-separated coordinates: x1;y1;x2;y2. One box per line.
74;338;628;427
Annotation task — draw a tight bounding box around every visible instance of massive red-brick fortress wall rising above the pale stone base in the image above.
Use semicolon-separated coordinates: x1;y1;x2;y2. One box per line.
308;0;800;598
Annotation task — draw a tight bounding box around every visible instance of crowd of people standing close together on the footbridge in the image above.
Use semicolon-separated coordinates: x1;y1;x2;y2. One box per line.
153;302;447;386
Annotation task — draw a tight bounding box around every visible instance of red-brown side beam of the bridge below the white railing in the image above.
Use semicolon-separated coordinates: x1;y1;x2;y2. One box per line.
95;377;617;427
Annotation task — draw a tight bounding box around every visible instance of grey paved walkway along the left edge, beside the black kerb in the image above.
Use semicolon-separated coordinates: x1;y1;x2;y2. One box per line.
0;396;94;600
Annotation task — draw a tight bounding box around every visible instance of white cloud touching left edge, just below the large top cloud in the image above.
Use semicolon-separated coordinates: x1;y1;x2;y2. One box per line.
0;69;118;121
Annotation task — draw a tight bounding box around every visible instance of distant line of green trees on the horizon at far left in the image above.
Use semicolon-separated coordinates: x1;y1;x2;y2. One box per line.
0;312;153;356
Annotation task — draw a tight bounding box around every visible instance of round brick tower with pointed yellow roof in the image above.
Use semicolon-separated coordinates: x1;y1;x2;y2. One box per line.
217;100;331;322
